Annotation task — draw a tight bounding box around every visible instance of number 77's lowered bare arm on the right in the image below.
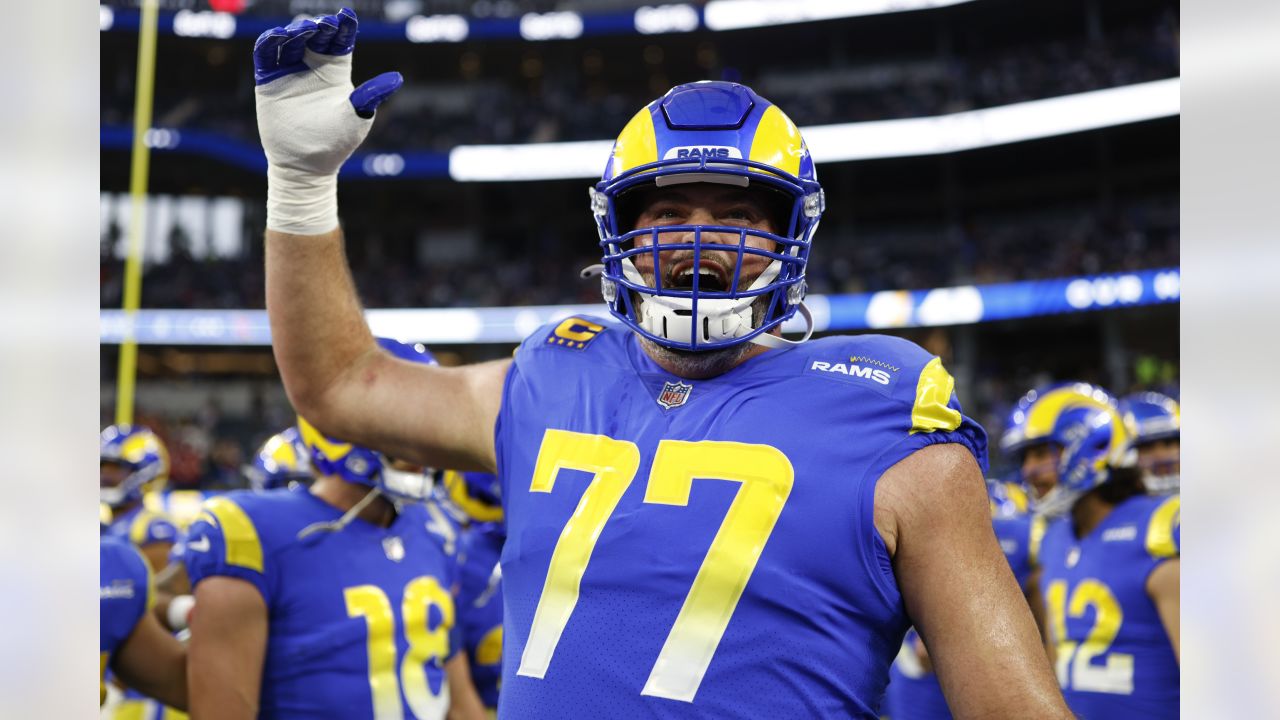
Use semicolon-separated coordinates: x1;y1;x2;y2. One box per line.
876;445;1073;719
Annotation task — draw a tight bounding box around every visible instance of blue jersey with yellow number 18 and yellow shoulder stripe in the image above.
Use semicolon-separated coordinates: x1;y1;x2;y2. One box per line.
183;487;457;719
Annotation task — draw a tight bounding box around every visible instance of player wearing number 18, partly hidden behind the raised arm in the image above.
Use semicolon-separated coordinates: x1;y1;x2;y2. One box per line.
177;341;483;720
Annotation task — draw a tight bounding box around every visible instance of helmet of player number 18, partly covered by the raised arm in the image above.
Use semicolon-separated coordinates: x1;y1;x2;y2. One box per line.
298;338;435;502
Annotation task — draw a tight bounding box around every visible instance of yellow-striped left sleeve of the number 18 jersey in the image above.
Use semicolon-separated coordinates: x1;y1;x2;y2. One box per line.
183;496;271;605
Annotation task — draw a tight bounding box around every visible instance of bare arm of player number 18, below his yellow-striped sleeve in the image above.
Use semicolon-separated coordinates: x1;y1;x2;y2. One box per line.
187;577;268;720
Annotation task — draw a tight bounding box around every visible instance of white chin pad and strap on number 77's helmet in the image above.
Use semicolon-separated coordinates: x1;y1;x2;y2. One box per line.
622;259;782;343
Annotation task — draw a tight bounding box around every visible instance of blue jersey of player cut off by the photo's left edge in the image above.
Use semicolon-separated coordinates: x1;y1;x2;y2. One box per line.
99;537;155;702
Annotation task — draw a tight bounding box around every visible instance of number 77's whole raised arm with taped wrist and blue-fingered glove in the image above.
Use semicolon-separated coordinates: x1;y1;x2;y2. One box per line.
253;8;509;470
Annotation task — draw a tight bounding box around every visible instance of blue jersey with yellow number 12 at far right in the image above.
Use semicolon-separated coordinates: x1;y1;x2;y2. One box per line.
1039;496;1181;720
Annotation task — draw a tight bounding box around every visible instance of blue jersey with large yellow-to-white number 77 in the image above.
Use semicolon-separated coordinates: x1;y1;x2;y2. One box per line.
495;318;986;717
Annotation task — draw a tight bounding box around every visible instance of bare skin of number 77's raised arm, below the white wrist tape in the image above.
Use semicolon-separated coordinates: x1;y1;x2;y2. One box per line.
266;229;509;470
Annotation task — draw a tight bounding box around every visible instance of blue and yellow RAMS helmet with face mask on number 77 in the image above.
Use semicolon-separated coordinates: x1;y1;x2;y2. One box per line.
584;81;826;350
